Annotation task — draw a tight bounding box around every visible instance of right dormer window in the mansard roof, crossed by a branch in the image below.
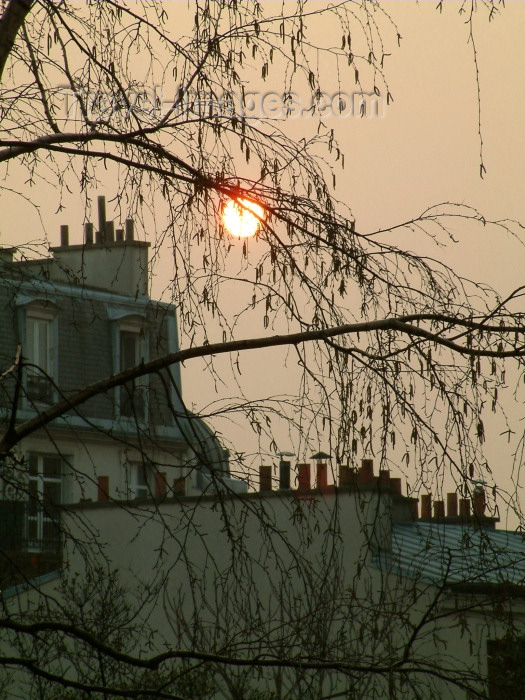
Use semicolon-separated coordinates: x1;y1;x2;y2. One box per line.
119;326;147;421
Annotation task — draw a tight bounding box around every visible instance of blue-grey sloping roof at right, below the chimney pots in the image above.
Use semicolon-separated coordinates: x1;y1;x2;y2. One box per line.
375;521;525;587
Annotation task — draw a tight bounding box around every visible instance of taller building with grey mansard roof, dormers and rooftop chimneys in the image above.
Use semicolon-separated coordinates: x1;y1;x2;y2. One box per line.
0;197;245;584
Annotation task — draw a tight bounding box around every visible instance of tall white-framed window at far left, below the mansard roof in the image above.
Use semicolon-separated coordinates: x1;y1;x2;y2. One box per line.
27;454;62;551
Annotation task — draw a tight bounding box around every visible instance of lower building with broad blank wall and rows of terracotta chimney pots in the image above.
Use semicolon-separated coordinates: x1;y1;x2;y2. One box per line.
4;460;525;700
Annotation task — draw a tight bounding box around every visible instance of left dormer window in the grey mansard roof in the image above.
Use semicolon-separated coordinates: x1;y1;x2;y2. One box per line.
24;311;56;403
